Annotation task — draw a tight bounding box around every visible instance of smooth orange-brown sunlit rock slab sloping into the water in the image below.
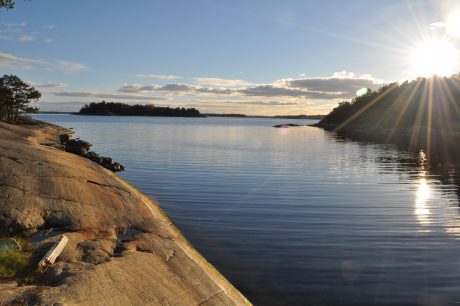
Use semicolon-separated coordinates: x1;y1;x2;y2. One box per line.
0;122;250;306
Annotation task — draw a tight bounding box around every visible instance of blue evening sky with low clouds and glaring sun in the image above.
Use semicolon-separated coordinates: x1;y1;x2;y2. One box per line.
0;0;460;115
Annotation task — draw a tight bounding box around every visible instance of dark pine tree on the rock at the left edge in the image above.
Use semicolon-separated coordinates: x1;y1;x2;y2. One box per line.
0;75;41;122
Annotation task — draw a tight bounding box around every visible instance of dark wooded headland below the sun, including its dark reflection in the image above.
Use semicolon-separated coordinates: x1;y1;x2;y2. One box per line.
313;74;460;155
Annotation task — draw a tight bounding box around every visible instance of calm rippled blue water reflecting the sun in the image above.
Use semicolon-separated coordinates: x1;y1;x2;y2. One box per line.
34;115;460;305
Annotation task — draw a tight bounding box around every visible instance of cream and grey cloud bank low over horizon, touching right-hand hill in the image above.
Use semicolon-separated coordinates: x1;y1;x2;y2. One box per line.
114;71;385;114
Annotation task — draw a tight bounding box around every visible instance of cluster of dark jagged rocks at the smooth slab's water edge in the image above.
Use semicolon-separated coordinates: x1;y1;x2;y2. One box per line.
59;134;125;172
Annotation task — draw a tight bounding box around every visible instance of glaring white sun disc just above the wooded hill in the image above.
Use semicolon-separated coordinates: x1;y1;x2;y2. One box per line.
410;38;458;77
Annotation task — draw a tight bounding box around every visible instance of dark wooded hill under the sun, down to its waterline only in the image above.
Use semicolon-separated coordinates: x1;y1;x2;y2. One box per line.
318;74;460;130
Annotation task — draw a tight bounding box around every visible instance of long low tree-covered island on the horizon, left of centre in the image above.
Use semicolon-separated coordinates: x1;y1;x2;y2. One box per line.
77;101;205;117
